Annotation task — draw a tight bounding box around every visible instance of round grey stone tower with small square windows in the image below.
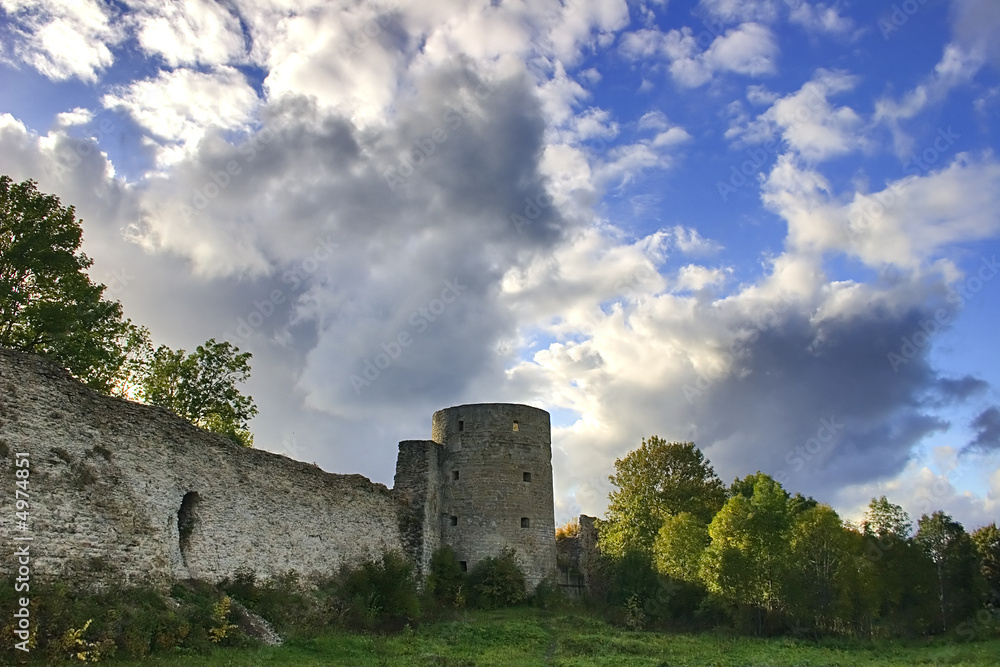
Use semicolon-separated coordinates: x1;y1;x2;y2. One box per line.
431;403;556;590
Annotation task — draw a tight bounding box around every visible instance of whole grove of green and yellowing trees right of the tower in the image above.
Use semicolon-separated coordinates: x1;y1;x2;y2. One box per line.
599;442;988;637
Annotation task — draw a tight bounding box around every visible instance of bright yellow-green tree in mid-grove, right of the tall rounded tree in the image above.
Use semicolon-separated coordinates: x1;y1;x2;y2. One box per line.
701;475;790;611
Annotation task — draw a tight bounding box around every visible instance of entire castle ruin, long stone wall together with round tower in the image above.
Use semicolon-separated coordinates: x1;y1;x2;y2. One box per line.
0;350;556;588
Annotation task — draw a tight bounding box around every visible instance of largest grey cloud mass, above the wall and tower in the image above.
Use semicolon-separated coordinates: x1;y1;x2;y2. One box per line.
125;61;565;444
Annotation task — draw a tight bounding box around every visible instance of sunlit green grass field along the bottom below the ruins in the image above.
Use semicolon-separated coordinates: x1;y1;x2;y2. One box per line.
103;608;1000;667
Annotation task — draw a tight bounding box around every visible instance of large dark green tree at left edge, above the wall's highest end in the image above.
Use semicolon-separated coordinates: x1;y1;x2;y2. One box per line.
0;176;134;392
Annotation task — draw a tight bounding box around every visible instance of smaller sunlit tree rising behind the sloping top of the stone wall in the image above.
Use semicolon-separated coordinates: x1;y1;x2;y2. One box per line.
138;338;257;447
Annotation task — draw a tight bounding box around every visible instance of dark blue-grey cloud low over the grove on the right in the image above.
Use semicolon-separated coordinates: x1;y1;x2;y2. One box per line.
680;292;980;500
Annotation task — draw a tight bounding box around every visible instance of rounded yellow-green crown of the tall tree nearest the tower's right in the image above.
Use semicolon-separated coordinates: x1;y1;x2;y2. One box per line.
599;435;726;558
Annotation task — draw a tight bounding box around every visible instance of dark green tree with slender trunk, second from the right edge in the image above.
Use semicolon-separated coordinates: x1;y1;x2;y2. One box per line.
913;511;982;631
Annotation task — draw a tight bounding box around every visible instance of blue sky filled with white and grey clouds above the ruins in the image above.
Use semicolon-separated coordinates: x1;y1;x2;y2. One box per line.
0;0;1000;530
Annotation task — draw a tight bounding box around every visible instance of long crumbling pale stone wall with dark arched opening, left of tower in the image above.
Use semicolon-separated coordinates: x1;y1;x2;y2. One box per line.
0;350;404;584
